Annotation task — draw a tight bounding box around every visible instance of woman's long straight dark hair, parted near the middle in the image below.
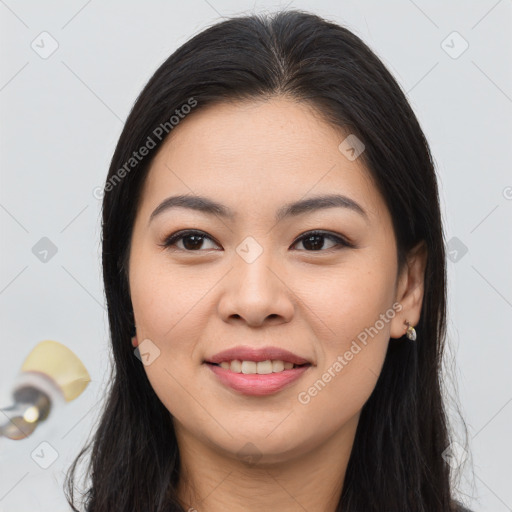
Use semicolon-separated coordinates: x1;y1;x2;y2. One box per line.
66;11;470;512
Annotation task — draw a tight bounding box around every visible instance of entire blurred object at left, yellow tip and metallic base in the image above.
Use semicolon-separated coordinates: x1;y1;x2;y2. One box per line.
0;340;91;440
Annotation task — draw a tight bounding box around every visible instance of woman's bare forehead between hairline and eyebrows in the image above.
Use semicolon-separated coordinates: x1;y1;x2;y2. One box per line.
143;98;386;224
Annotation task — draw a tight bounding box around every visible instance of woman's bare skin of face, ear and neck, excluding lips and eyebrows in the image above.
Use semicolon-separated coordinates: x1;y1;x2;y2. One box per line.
129;97;426;512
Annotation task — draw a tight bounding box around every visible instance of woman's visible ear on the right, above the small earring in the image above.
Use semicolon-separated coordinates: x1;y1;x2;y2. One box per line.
390;240;428;338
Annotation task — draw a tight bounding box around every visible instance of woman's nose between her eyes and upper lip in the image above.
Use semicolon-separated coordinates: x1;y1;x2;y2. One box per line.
218;250;296;327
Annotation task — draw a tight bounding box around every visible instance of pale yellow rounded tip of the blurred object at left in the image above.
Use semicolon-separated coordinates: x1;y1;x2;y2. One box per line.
21;340;91;402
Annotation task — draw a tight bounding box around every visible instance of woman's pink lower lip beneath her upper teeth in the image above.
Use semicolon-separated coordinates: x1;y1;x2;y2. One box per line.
206;363;311;396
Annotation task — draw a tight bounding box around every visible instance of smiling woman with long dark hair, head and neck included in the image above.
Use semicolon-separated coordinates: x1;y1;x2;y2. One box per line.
68;11;474;512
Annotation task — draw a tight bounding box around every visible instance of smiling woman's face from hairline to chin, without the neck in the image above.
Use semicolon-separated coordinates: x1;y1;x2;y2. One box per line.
129;98;421;462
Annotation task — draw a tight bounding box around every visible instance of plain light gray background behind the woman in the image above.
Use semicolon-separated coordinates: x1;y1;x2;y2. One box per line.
0;0;512;512
